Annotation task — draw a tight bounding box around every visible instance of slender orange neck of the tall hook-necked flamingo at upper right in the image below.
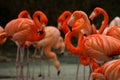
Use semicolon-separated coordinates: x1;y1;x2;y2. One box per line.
99;10;109;34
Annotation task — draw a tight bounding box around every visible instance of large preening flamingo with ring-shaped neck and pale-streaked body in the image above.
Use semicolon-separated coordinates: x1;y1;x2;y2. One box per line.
65;10;120;65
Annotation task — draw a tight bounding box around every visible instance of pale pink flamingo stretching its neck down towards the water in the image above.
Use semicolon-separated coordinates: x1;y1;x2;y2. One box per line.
31;26;60;75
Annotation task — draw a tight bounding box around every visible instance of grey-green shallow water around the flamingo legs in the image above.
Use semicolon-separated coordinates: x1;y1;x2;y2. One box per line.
0;55;92;80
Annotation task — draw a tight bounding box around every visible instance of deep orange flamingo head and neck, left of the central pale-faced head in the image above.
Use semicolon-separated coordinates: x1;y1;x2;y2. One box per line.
57;11;72;34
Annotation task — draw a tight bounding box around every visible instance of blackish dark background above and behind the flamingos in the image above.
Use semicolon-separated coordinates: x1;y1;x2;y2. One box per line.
0;0;120;57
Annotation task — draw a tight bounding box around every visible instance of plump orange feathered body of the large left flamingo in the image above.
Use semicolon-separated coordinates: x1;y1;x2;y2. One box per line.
5;18;45;42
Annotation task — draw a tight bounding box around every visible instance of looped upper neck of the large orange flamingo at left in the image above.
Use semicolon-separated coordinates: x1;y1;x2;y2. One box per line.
33;11;48;30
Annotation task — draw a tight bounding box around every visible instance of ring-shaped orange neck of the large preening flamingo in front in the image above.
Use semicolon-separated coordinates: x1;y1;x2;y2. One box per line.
65;31;83;55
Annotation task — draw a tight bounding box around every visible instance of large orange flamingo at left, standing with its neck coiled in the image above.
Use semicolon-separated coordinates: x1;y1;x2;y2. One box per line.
5;12;45;79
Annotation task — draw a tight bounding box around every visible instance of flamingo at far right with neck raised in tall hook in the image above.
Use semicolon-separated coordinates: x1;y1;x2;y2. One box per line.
89;7;120;46
